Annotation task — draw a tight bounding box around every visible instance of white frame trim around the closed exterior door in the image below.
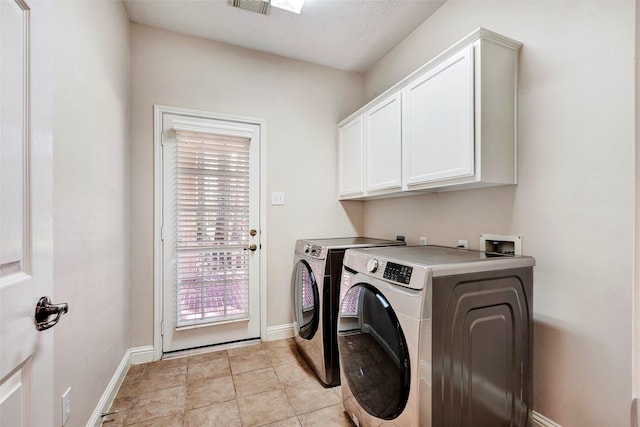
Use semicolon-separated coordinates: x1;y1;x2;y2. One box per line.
153;104;267;361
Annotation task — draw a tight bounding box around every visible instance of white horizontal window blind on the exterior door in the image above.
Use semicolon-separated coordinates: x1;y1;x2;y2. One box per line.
175;130;250;328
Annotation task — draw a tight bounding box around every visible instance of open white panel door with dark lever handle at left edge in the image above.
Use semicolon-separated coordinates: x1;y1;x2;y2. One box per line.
0;0;58;427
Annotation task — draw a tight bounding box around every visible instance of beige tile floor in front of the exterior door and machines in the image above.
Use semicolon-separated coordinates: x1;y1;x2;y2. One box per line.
103;339;352;427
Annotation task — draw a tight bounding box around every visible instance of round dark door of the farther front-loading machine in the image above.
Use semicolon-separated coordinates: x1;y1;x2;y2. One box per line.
294;260;320;340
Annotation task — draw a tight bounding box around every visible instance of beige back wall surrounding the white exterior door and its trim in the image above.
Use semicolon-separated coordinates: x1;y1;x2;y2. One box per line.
131;24;362;347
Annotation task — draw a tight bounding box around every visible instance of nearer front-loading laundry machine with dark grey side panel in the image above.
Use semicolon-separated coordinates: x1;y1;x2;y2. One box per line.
338;246;534;427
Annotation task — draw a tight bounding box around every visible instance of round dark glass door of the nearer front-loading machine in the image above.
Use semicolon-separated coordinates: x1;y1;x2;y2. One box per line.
338;283;411;420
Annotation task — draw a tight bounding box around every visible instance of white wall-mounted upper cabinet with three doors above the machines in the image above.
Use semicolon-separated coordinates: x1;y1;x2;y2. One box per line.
338;28;521;199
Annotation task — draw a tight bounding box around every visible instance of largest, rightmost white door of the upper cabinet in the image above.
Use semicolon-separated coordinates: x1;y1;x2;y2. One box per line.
403;46;474;187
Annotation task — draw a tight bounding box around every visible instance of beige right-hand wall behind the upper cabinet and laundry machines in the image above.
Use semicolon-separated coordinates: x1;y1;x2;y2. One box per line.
364;0;635;427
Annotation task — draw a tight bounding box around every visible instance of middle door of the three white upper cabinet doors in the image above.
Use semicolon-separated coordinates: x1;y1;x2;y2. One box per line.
365;92;402;191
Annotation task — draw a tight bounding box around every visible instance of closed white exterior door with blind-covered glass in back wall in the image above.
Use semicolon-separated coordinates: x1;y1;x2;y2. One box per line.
162;113;260;353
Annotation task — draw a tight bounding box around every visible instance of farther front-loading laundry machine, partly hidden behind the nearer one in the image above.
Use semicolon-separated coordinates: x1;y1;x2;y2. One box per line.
292;237;405;386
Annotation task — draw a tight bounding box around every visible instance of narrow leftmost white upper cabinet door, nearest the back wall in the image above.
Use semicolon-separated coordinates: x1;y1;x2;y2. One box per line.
338;116;364;197
